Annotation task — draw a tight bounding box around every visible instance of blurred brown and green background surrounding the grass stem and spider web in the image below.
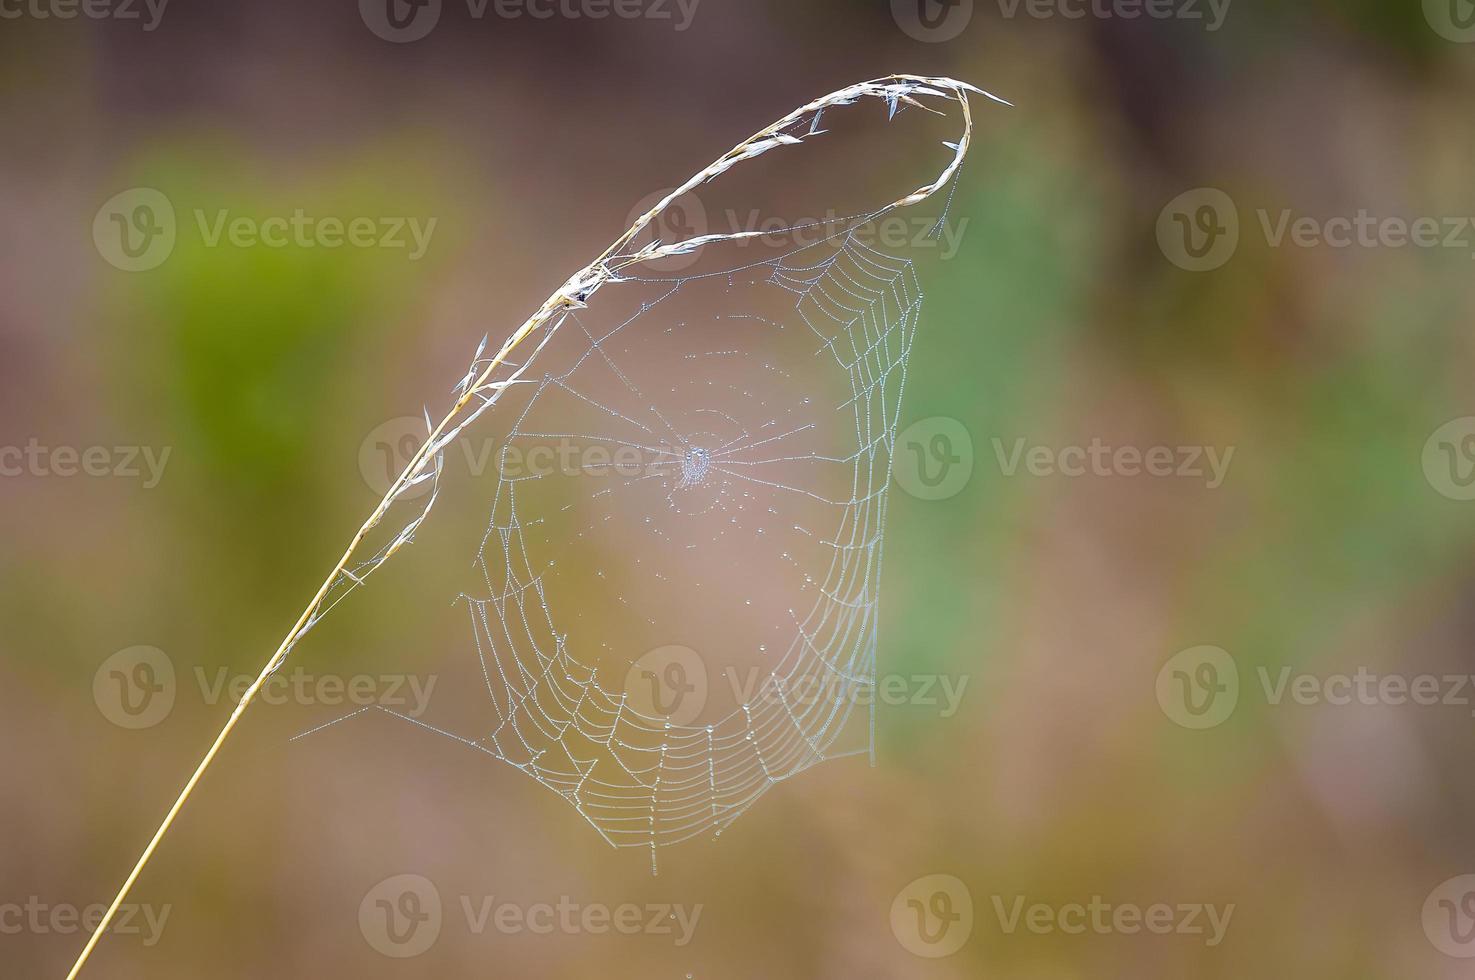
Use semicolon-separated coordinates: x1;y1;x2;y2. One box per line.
0;0;1475;980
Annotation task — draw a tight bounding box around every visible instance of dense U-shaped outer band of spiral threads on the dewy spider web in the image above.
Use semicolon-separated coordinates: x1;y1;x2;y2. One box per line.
454;233;922;867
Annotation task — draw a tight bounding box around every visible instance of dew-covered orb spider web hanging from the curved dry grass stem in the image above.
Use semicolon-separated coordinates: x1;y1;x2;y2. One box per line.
466;232;920;849
